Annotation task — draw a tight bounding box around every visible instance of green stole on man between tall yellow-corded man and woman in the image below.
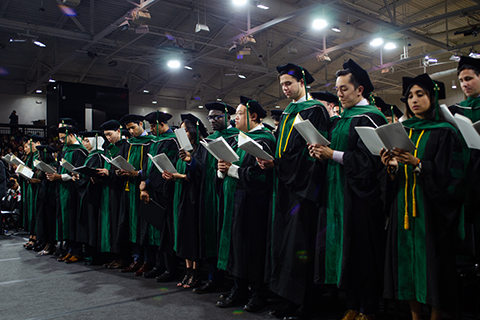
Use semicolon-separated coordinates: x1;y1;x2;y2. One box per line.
325;105;387;284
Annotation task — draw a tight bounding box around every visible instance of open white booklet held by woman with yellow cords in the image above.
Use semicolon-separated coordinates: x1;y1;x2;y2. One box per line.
355;122;415;156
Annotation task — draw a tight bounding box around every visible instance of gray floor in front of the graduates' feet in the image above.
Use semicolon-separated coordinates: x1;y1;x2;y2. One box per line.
0;235;472;320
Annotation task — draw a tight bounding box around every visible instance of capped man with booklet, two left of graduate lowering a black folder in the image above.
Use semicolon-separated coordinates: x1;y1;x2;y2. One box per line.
97;120;129;269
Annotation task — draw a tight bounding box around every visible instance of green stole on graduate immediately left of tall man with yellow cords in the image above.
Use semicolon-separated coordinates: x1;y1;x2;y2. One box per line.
217;129;275;270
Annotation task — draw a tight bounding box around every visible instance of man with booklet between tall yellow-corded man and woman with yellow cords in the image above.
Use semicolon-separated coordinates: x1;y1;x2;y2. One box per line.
309;59;387;320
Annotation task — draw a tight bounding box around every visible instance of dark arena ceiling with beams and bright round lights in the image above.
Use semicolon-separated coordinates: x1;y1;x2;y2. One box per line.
0;0;480;109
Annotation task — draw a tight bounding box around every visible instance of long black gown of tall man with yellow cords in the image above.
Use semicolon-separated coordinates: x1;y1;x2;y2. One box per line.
266;103;330;304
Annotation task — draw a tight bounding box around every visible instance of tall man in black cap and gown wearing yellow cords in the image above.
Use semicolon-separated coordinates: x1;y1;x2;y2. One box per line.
257;63;330;318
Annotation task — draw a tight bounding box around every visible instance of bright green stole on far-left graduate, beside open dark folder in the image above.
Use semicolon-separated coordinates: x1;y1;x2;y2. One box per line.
57;143;86;240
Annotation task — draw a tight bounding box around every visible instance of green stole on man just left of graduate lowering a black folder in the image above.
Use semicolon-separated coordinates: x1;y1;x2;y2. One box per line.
125;135;153;243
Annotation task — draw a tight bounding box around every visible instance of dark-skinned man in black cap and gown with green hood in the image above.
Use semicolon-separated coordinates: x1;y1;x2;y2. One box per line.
187;102;238;294
